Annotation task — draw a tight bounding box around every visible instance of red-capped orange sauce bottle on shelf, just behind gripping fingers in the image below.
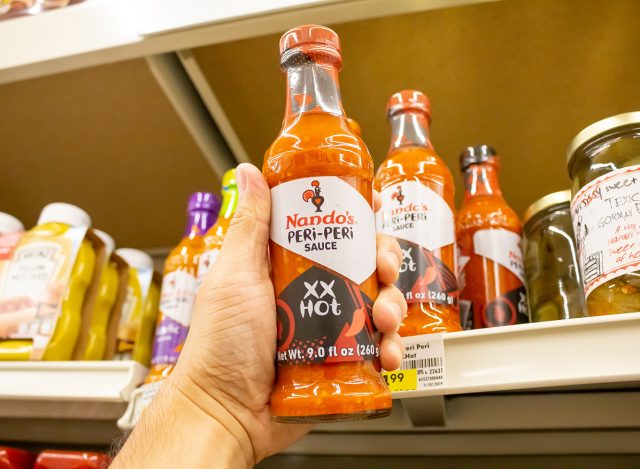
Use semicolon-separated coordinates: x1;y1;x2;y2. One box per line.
375;90;461;336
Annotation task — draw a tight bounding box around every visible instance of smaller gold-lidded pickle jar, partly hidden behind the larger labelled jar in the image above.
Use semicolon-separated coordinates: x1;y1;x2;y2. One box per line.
523;190;586;322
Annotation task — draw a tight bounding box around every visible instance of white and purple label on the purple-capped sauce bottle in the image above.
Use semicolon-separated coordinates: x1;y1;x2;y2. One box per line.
151;270;196;365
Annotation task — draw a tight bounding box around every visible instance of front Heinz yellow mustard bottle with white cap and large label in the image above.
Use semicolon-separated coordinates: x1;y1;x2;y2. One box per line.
0;203;95;360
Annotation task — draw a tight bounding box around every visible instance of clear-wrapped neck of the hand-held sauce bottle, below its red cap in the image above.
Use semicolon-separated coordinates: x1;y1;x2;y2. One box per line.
285;61;344;121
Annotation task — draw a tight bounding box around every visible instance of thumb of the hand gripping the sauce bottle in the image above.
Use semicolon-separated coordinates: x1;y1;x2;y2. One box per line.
220;163;271;275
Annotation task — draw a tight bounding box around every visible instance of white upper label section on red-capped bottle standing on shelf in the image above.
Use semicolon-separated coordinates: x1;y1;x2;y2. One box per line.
376;181;455;251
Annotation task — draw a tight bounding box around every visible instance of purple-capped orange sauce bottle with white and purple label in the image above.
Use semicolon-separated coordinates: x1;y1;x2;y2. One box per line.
146;192;220;383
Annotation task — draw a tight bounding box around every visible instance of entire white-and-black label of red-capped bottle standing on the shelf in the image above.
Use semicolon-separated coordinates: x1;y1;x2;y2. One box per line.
376;181;458;305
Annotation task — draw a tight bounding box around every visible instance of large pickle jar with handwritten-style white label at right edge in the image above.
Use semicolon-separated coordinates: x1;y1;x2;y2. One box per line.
567;112;640;316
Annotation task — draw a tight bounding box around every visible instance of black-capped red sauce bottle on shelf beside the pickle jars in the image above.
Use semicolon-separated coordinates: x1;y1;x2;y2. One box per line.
457;145;529;329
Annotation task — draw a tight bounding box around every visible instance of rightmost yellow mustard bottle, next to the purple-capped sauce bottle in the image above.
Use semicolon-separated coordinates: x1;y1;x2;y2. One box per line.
115;248;153;360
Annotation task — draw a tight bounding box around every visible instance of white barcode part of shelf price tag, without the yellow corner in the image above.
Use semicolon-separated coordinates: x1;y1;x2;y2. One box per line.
400;334;447;390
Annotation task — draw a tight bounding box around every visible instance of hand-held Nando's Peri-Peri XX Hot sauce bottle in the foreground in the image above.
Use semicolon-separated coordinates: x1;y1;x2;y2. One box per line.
263;25;391;422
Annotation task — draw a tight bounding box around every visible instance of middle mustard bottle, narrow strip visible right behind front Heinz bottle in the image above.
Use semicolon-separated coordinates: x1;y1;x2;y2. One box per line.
82;230;118;360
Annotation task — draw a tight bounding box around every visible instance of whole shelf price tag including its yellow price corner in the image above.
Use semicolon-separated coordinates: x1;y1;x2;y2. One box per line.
383;334;447;391
